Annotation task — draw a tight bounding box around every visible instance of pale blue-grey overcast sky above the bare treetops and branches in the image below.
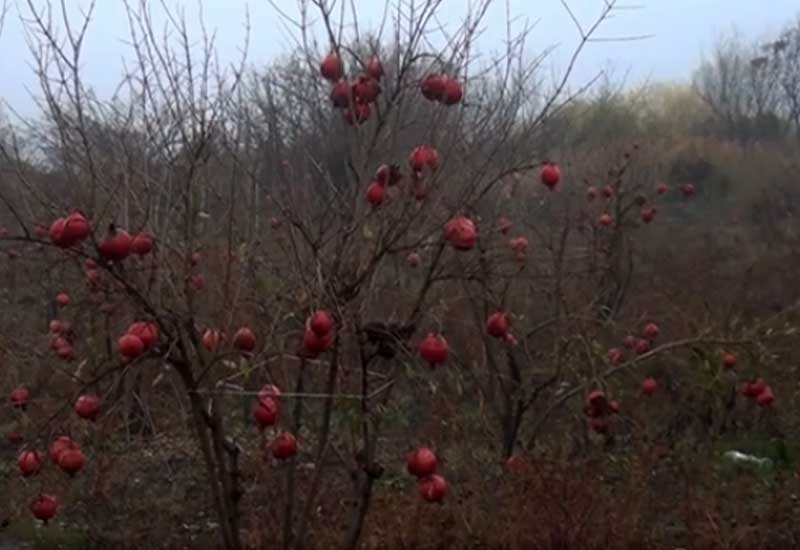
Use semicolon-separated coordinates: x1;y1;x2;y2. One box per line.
0;0;800;112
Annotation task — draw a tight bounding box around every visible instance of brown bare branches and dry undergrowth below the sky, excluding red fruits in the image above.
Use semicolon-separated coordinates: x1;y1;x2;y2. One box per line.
0;0;800;550
